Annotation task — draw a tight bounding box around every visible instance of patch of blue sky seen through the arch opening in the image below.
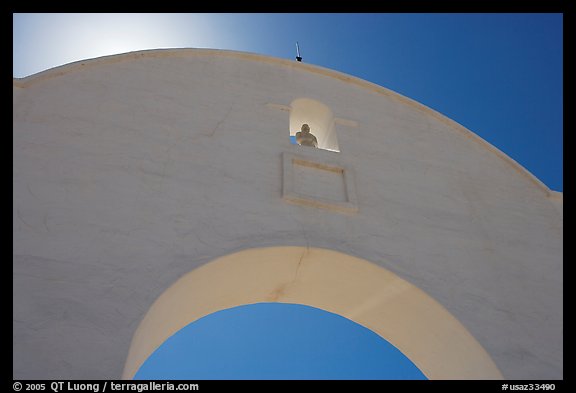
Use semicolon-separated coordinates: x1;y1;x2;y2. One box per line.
135;303;427;380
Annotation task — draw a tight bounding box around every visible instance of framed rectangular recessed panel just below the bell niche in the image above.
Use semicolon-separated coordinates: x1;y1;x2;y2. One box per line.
282;153;358;213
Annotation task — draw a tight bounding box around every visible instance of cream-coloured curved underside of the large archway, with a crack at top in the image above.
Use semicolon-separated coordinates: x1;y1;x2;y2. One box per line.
123;247;502;379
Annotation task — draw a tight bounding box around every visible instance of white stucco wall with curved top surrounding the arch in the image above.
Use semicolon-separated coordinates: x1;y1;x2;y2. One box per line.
13;50;563;379
